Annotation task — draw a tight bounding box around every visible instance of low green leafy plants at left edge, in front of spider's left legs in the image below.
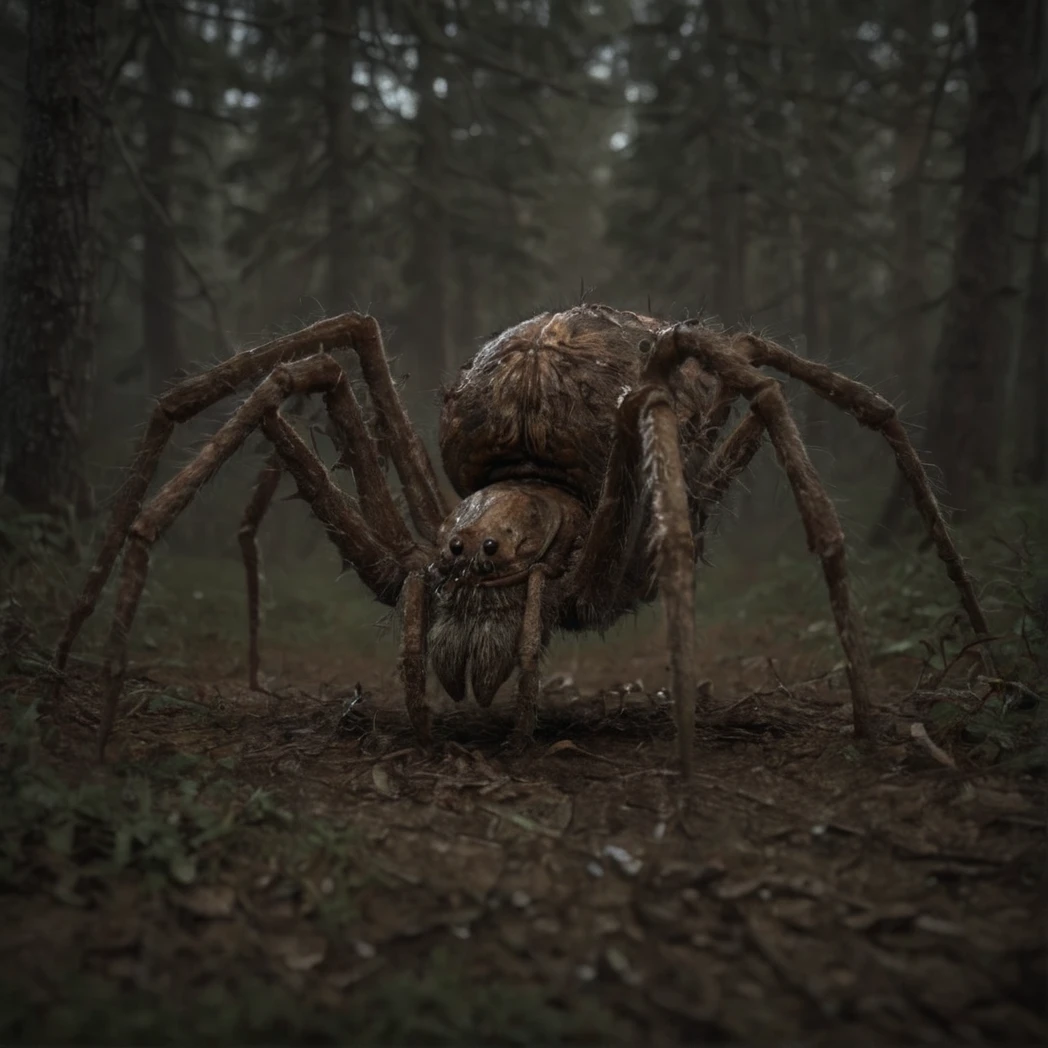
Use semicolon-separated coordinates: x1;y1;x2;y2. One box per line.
0;695;290;907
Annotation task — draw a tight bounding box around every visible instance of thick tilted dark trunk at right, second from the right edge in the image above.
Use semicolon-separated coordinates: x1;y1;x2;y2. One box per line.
927;0;1036;510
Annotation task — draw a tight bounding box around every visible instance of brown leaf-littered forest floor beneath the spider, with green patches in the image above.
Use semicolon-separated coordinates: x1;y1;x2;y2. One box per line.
0;503;1048;1045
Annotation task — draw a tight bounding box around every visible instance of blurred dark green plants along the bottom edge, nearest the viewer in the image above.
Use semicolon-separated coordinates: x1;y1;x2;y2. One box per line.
0;948;626;1046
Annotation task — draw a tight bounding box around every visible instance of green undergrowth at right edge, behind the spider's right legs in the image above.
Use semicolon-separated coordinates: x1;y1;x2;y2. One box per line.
697;489;1048;771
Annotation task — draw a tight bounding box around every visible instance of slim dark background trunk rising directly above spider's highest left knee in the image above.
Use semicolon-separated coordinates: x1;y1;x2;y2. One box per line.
324;0;357;313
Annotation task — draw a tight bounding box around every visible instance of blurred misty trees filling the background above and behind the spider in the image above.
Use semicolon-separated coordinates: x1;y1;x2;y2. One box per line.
0;0;1048;549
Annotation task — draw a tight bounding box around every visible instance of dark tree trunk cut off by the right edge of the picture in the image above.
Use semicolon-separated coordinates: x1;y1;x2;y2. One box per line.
1016;0;1048;484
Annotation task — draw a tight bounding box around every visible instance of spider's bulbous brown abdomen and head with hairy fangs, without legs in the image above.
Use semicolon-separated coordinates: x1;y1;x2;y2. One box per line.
429;306;715;706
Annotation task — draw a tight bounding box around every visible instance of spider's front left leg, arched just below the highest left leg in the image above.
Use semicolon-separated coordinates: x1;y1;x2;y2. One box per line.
99;355;407;757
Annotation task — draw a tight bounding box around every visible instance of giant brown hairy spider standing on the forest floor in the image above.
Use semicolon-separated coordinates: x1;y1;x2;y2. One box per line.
56;305;987;776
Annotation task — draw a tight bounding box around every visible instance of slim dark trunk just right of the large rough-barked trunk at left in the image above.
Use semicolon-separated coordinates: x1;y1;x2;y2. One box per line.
141;5;182;393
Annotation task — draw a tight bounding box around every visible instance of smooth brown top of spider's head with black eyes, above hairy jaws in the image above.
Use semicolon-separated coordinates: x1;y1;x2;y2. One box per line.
430;481;585;588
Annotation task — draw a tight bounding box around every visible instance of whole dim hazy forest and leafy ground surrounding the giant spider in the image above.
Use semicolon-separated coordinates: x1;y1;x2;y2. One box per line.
0;0;1048;1045
